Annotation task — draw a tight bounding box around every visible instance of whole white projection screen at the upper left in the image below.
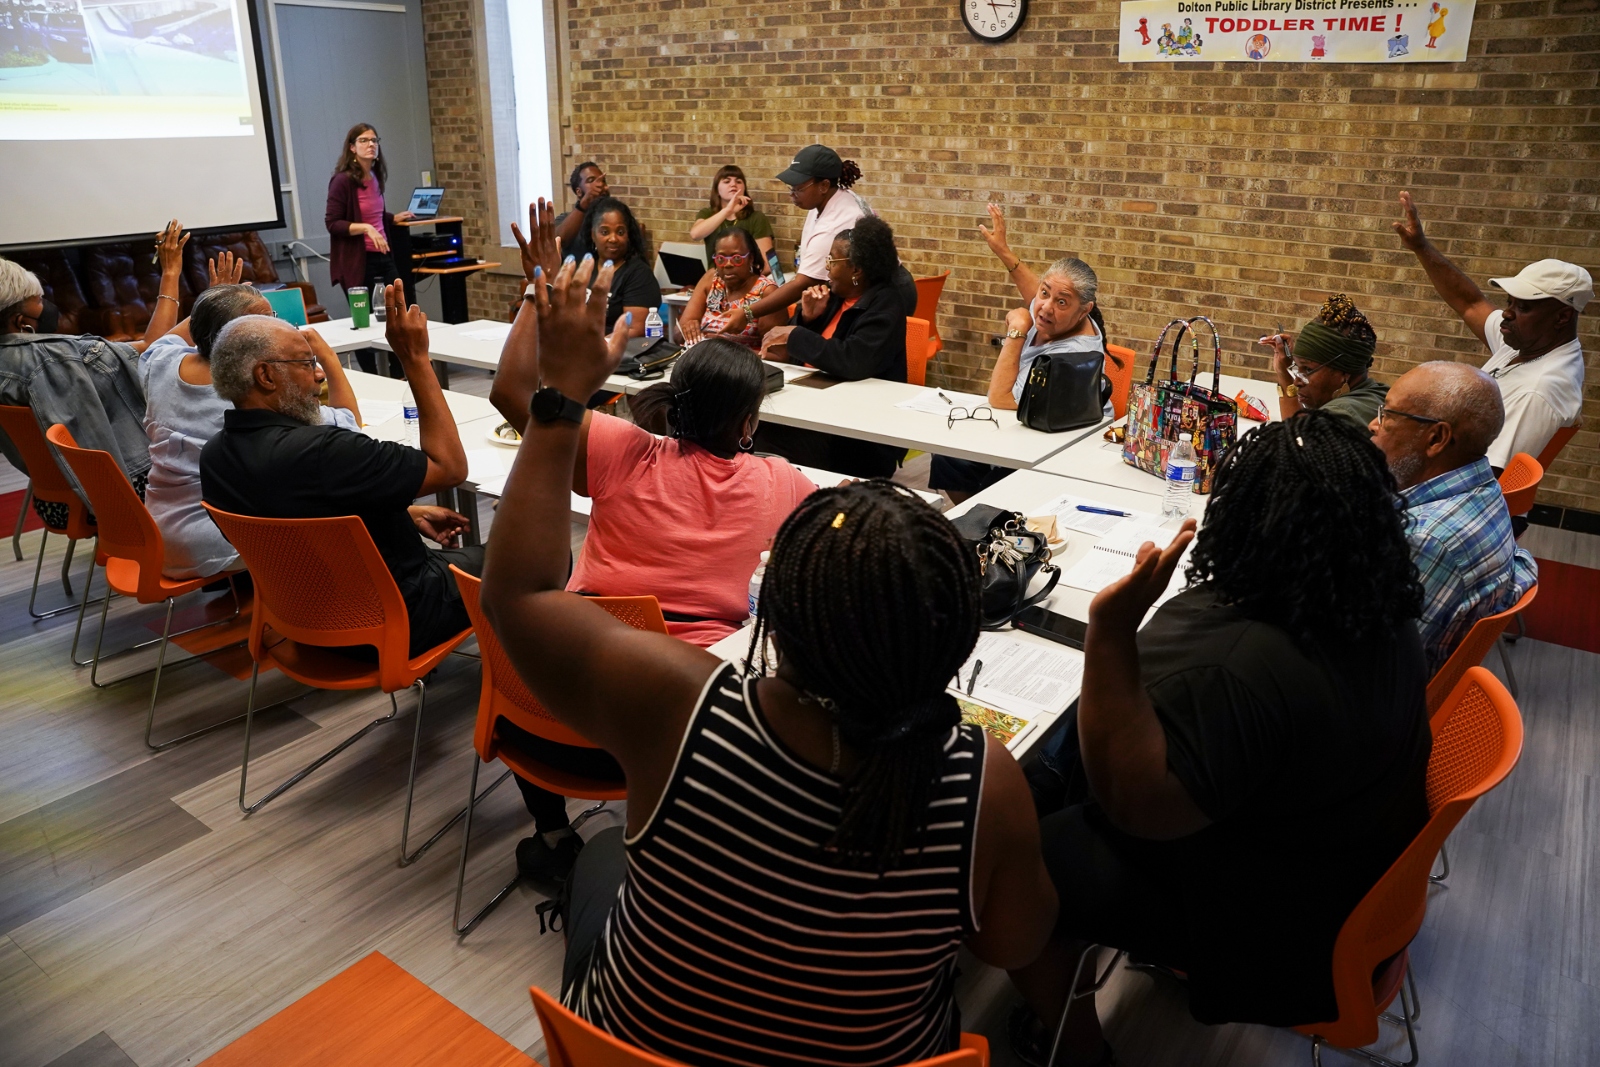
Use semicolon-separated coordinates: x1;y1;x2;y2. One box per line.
0;0;282;246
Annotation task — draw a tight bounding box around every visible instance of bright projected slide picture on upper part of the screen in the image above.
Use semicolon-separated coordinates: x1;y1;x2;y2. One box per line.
0;0;254;141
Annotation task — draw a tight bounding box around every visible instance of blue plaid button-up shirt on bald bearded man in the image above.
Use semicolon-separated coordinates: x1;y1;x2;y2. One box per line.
1405;458;1539;672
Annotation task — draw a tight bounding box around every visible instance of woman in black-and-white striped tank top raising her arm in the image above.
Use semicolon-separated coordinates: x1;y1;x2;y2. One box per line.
483;255;1056;1067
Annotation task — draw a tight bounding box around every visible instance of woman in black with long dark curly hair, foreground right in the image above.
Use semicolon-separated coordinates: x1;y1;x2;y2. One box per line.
1011;411;1432;1067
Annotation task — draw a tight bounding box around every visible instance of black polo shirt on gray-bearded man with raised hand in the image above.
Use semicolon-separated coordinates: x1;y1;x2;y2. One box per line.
200;408;435;614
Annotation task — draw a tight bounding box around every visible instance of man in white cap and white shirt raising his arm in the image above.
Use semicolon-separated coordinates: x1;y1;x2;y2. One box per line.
1394;192;1595;474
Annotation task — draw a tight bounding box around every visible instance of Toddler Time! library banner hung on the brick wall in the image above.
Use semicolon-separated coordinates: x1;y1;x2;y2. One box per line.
1117;0;1475;62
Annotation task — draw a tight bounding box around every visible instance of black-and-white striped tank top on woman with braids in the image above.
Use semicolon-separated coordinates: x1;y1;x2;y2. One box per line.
566;664;984;1067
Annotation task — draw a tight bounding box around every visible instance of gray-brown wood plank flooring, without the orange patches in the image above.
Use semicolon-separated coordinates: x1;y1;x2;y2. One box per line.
0;373;1600;1067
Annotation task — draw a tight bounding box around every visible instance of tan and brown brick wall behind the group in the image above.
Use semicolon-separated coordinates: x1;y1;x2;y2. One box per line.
424;0;1600;510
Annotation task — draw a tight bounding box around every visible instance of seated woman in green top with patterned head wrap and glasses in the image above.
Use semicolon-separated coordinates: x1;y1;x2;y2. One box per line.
1261;293;1389;430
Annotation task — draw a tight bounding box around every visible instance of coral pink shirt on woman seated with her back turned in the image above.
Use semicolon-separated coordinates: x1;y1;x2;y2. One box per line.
566;413;816;646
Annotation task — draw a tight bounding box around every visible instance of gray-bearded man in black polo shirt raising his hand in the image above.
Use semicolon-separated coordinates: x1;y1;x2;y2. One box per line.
200;286;483;656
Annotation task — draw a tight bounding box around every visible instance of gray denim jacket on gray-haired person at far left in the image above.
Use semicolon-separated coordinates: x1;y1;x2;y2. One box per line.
0;333;150;496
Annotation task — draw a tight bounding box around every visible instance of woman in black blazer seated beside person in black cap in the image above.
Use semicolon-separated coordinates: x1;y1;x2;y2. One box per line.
755;216;906;478
